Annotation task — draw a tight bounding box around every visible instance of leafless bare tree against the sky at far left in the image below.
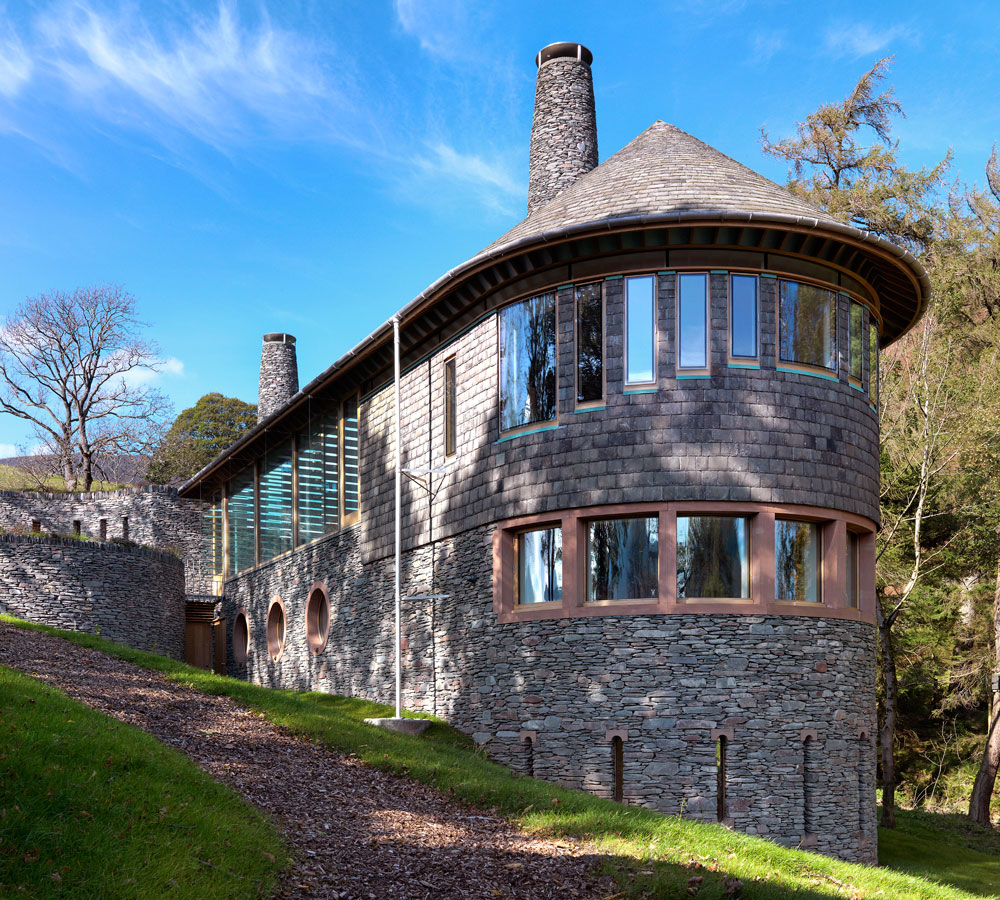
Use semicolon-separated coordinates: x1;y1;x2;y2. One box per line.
0;285;170;490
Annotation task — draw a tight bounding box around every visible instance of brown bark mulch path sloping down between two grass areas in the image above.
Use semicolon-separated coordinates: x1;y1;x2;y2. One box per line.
0;623;613;900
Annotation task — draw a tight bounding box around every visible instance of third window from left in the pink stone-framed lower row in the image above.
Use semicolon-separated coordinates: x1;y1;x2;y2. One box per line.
677;516;750;599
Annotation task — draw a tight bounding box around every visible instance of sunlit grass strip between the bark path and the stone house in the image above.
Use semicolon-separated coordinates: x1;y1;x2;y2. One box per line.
0;617;1000;900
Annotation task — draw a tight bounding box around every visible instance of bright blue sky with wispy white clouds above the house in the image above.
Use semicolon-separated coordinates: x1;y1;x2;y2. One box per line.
0;0;1000;456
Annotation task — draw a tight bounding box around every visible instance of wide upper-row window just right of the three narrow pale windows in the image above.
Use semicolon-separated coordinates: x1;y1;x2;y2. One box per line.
778;281;837;372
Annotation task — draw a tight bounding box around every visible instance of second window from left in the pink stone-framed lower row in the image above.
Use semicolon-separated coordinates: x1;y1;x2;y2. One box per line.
587;516;659;603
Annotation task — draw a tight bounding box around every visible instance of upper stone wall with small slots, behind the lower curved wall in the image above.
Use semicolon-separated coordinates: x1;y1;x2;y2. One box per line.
0;485;205;594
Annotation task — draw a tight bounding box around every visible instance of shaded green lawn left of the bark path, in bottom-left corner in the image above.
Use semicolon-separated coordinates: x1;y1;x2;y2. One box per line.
0;666;286;900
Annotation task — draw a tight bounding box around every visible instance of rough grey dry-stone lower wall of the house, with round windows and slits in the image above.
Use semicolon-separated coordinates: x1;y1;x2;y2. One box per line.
223;527;875;862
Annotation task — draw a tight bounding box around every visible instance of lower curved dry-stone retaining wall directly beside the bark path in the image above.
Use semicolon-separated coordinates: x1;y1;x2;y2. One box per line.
0;535;184;659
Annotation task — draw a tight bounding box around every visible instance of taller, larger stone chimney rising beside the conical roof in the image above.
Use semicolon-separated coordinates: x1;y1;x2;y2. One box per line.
528;43;597;216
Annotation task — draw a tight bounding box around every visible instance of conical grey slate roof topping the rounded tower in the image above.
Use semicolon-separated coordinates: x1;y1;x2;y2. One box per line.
486;121;839;252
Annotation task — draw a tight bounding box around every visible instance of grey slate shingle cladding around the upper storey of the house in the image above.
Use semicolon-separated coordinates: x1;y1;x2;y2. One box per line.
361;273;879;562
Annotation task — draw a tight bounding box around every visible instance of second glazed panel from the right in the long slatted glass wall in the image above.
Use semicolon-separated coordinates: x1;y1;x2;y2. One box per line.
298;409;340;544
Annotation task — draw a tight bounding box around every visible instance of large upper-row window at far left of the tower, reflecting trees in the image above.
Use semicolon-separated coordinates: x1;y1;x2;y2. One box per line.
498;294;556;431
